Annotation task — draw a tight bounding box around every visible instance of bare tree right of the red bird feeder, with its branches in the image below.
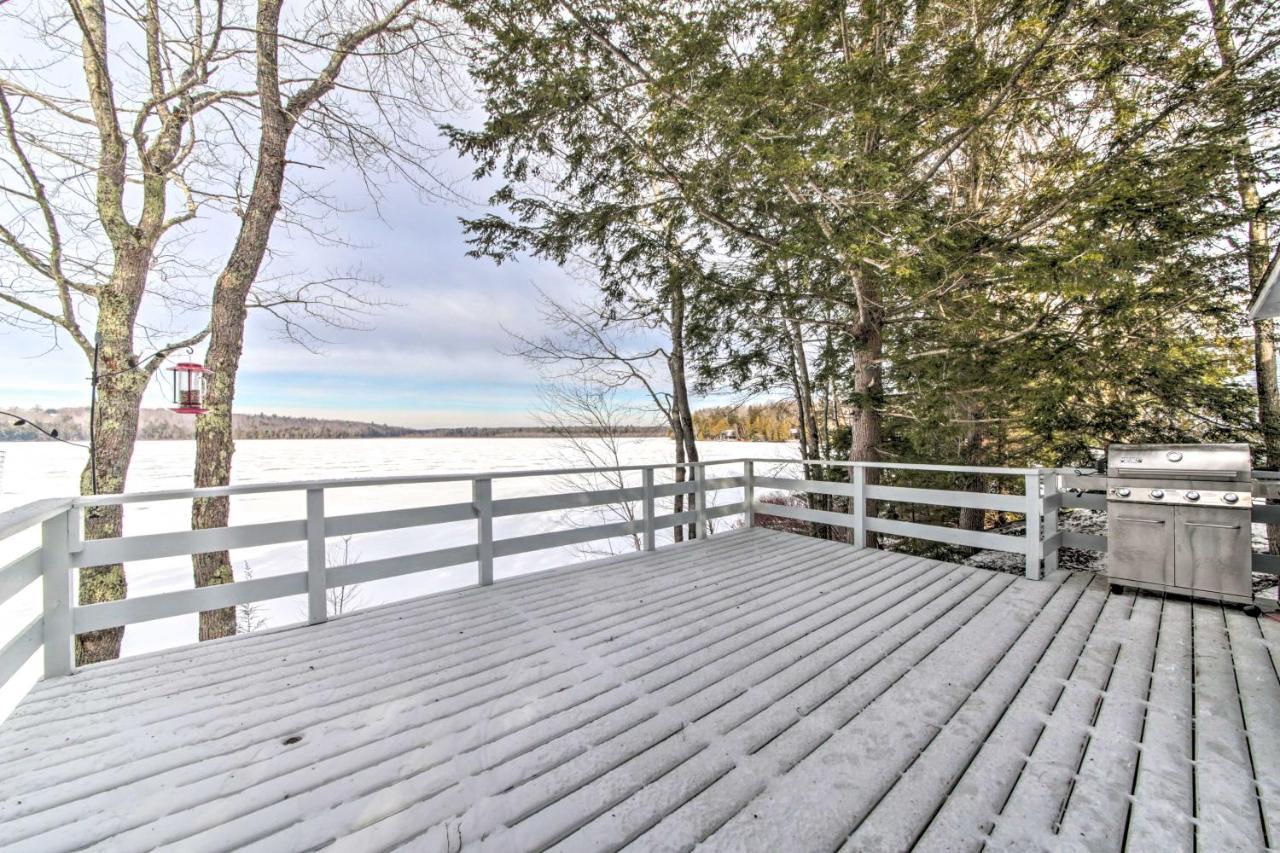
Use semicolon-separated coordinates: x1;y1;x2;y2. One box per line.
183;0;452;639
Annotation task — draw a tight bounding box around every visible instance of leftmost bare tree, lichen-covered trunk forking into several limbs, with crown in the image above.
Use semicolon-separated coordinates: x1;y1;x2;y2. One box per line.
0;0;242;663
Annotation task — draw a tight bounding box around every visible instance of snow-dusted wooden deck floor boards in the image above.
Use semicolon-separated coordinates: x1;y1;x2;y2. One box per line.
0;529;1280;852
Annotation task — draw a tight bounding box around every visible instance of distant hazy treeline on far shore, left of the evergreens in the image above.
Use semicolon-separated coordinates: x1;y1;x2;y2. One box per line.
0;407;666;442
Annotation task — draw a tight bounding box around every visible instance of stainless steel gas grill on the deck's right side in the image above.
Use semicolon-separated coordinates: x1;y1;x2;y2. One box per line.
1107;444;1253;603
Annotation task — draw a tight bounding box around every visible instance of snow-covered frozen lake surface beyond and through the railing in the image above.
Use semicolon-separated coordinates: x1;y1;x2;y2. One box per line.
0;438;797;716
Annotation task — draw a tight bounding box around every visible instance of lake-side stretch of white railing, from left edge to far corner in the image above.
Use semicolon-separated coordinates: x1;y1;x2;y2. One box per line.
0;460;746;686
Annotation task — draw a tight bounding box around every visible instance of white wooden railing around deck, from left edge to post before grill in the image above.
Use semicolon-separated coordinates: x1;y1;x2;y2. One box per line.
0;450;1062;686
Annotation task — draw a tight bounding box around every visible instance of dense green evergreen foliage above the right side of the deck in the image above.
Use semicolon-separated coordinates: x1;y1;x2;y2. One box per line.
451;0;1280;465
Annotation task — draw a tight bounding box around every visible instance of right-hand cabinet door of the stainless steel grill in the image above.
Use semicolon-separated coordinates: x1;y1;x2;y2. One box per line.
1176;506;1252;596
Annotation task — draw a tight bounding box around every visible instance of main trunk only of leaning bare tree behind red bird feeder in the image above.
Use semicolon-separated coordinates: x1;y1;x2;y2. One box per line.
191;3;292;640
